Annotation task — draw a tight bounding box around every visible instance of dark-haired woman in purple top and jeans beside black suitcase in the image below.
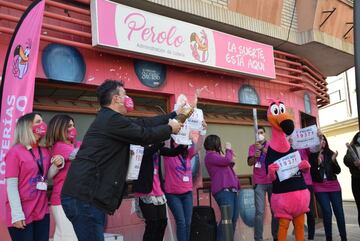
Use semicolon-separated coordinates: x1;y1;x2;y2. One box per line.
204;135;240;241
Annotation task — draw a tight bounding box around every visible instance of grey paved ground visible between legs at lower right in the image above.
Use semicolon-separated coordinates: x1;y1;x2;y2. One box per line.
287;202;360;241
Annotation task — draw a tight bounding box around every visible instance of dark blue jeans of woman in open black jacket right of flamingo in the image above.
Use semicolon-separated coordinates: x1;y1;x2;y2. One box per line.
315;191;346;240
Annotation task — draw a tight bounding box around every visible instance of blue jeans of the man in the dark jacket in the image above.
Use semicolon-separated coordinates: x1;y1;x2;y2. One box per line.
61;195;105;241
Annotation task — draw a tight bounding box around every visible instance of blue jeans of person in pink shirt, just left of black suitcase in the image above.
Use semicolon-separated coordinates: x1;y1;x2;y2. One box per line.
166;192;193;241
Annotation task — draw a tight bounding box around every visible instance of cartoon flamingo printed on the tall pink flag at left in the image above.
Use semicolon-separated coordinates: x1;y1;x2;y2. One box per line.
13;39;31;79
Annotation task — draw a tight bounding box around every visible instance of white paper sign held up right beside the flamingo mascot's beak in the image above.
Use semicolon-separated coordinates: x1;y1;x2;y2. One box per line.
291;125;320;149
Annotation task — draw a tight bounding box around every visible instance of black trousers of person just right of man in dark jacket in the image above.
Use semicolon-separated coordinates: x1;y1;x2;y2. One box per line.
139;199;167;241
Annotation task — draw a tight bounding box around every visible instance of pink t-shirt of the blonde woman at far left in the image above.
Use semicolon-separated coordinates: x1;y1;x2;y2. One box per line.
5;144;50;227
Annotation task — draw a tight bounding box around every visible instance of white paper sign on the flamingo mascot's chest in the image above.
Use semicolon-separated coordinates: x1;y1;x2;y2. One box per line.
274;151;301;182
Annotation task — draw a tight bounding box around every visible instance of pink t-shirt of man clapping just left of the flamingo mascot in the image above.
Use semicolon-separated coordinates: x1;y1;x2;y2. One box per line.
248;142;272;184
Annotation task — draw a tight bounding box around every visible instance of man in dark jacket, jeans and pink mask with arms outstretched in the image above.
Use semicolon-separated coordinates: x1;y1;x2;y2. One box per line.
61;80;181;241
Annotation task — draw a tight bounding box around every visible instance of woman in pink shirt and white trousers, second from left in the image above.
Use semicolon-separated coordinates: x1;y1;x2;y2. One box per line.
46;115;81;241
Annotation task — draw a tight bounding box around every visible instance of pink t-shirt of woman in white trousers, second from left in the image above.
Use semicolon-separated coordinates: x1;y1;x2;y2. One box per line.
50;141;81;205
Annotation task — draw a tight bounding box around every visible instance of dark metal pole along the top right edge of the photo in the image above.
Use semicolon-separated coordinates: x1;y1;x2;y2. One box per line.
354;0;360;130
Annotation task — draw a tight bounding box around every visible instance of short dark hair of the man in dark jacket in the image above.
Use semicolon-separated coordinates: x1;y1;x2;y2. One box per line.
96;79;124;106
